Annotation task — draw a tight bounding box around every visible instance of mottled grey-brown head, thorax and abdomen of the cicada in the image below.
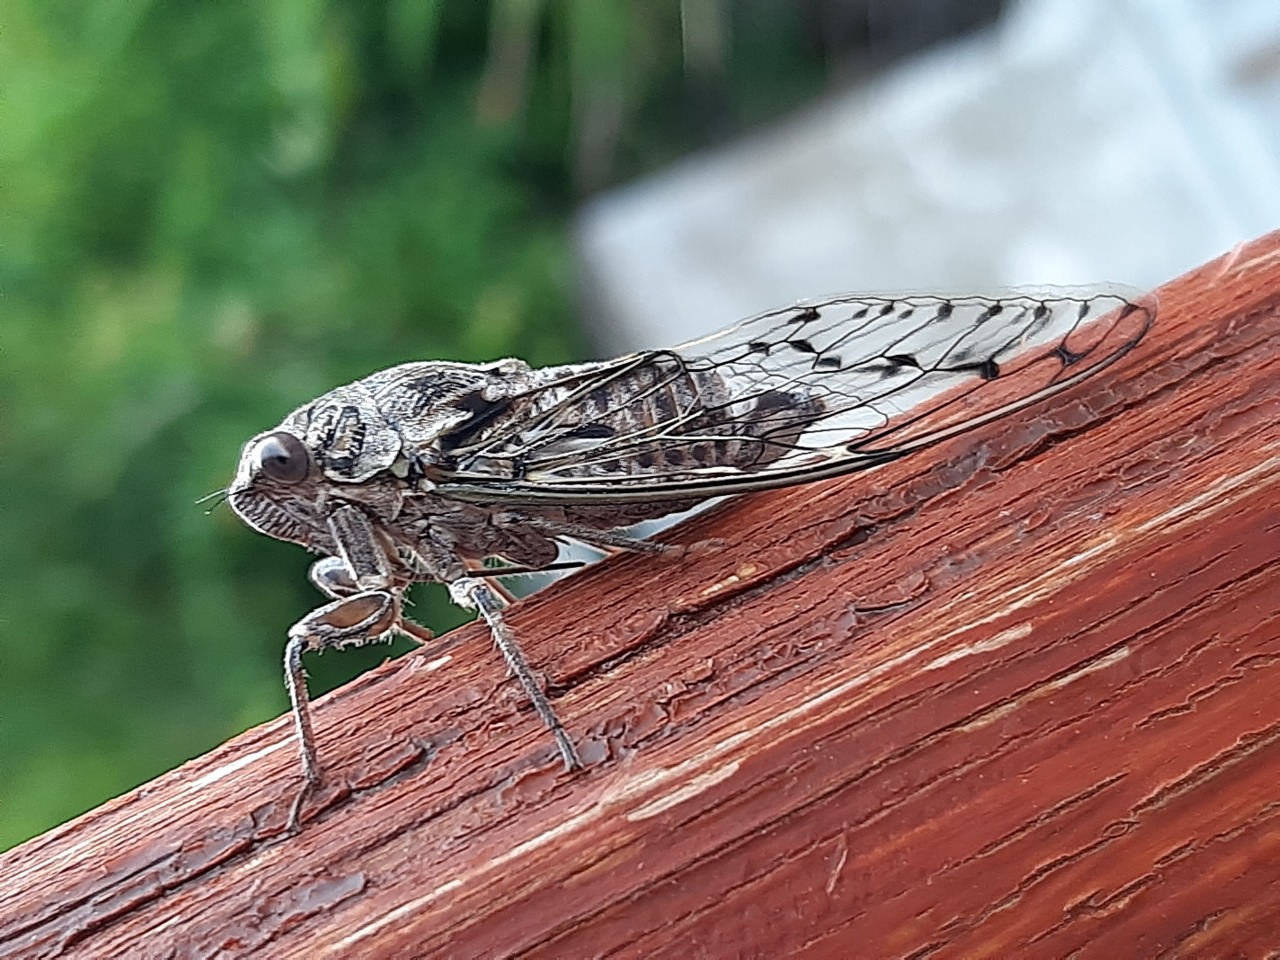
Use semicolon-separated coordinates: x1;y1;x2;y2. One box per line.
230;357;822;584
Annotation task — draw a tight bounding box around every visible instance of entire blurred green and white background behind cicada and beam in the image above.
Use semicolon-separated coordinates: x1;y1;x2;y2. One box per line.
0;0;1280;849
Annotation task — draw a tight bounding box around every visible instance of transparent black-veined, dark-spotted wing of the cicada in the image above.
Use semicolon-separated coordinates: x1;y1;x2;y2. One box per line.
436;288;1155;503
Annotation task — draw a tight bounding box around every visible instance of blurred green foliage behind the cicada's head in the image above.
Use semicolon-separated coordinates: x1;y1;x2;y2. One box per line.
0;0;822;847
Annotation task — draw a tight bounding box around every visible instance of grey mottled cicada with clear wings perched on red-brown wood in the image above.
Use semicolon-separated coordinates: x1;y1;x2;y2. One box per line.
227;288;1155;828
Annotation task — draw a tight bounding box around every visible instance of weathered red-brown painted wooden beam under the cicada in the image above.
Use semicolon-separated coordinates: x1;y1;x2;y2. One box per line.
0;234;1280;959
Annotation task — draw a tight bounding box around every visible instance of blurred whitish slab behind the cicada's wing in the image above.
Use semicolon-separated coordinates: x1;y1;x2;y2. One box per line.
577;0;1280;355
